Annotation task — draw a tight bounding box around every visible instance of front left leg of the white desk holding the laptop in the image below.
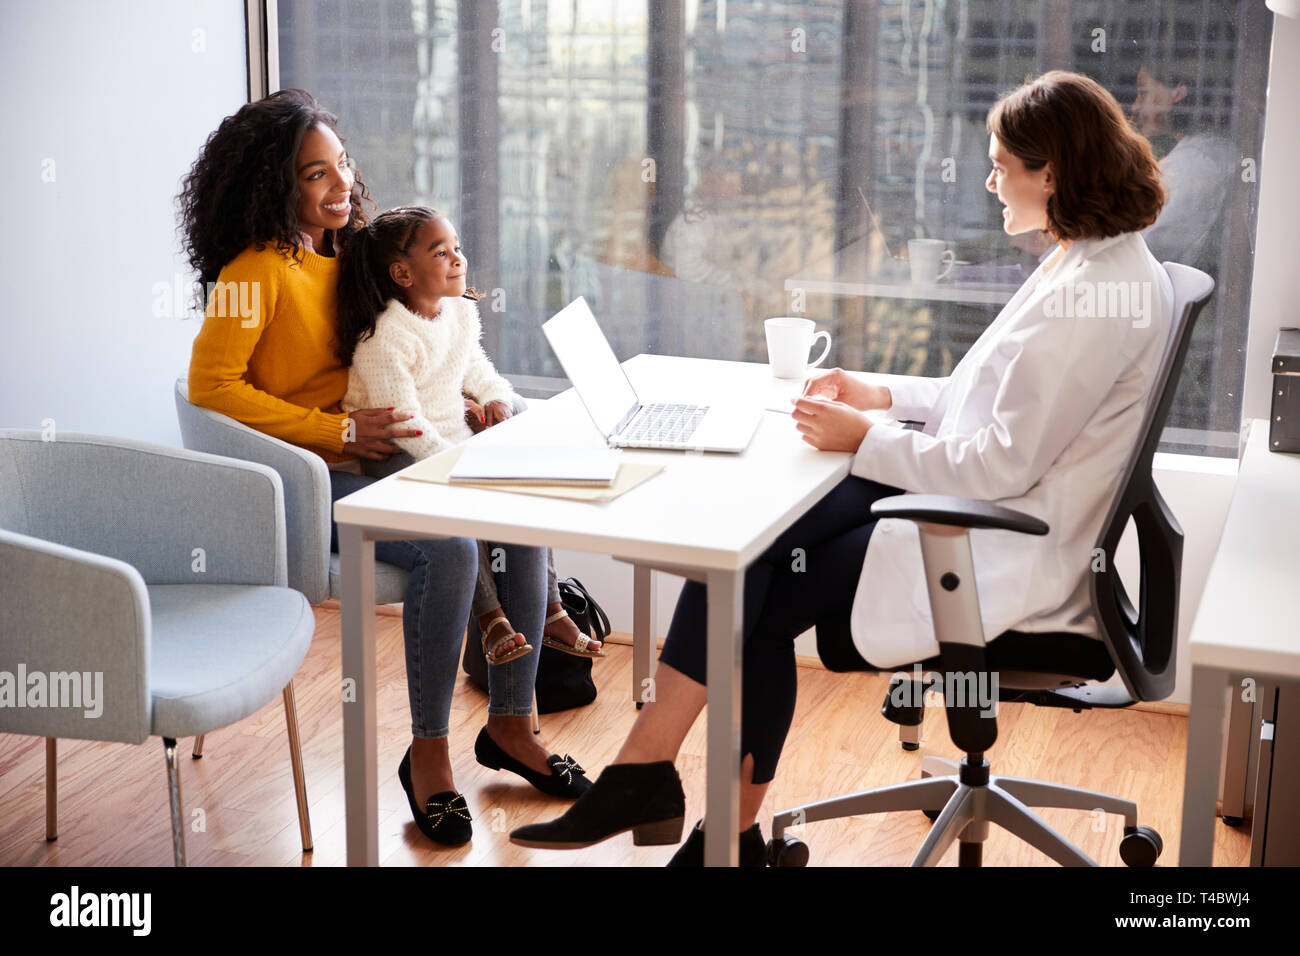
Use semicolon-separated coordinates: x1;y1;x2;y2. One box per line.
338;524;380;866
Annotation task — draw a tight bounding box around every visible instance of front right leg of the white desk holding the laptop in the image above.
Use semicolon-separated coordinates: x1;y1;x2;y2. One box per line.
705;570;745;866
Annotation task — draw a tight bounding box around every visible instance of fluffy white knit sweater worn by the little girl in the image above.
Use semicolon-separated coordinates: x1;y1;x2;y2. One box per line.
343;297;515;459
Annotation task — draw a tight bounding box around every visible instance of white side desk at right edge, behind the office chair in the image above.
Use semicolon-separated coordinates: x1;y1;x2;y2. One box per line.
1178;419;1300;866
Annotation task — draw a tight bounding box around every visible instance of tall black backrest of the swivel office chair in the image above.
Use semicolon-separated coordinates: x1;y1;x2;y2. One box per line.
1089;263;1214;700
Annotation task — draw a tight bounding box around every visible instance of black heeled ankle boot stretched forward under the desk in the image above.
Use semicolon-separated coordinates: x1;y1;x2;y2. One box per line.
510;760;686;849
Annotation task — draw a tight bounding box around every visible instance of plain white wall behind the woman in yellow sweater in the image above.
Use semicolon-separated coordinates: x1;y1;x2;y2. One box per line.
0;0;247;445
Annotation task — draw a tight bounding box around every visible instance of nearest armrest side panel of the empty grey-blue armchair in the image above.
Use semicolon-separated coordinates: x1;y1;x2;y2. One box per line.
0;529;152;744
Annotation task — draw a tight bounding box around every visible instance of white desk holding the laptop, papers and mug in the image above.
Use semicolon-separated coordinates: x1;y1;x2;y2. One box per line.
334;355;850;866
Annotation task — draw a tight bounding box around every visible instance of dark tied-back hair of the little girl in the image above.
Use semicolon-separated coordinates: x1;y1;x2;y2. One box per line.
338;206;482;365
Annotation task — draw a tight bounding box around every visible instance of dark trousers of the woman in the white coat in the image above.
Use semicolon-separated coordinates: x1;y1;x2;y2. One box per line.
659;477;904;783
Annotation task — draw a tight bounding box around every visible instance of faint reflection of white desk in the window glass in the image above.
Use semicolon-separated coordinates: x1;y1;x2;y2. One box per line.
785;235;1028;306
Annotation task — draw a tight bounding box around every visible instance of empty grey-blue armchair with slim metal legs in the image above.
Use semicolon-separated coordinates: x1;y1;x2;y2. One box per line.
0;431;315;866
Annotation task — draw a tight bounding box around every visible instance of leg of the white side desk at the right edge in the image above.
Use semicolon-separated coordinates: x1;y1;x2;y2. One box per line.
1178;665;1229;866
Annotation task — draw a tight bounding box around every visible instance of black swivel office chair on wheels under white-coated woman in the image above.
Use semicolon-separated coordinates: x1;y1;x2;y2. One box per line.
768;263;1214;866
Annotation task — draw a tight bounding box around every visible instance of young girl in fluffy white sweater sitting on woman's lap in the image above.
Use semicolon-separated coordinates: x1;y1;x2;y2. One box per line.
338;206;605;665
